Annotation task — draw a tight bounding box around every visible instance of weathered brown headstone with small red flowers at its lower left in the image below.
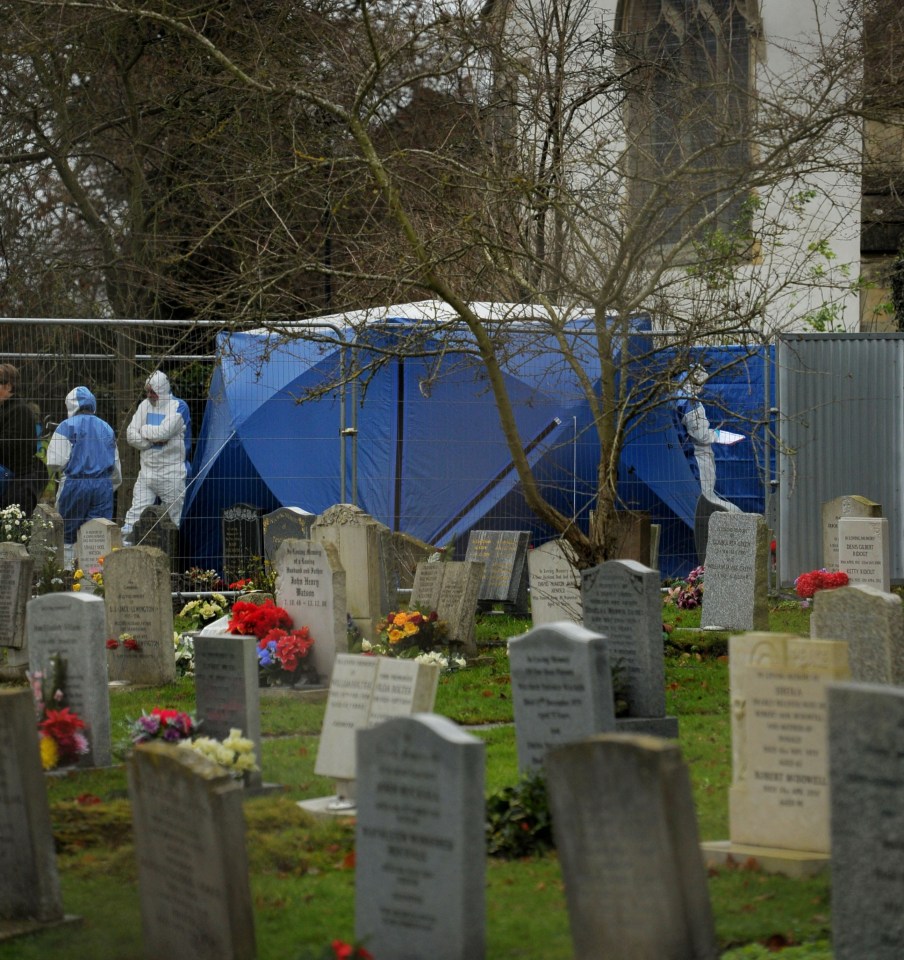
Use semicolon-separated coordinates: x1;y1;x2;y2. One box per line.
104;547;176;686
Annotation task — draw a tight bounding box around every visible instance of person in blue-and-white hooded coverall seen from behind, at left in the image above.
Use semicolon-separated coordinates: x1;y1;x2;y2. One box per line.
47;387;122;563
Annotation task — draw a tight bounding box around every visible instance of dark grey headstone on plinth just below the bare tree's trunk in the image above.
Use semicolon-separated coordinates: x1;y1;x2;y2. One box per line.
581;560;678;737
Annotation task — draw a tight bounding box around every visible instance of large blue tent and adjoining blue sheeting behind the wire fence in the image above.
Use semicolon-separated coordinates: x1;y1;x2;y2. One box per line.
183;301;764;576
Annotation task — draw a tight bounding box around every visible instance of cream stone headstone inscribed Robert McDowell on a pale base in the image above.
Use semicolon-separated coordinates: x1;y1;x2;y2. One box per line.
704;633;848;875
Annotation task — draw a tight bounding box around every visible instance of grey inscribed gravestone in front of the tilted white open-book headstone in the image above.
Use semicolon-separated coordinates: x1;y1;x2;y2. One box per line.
355;715;486;960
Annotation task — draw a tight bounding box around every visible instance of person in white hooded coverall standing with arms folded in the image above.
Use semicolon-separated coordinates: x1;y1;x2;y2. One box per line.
122;370;191;538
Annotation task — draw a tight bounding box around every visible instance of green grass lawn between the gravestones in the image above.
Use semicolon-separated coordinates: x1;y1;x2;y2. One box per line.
0;604;831;960
